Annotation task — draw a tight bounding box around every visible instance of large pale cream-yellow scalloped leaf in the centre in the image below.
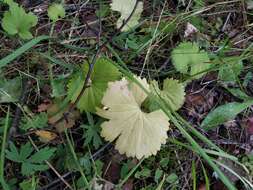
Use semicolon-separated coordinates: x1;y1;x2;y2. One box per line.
97;78;169;159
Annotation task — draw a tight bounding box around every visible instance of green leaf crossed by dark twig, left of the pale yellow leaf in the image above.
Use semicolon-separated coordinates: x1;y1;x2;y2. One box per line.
68;58;120;112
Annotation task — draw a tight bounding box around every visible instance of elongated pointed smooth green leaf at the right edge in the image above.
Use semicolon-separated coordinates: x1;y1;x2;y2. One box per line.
201;100;253;130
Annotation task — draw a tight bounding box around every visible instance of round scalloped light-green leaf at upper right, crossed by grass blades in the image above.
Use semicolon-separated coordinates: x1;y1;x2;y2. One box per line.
171;42;211;79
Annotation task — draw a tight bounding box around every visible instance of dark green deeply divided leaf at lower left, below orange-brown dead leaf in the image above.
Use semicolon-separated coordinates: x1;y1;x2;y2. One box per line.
6;142;56;176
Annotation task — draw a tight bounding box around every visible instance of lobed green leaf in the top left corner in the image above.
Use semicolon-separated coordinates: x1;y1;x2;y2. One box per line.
2;1;38;39
